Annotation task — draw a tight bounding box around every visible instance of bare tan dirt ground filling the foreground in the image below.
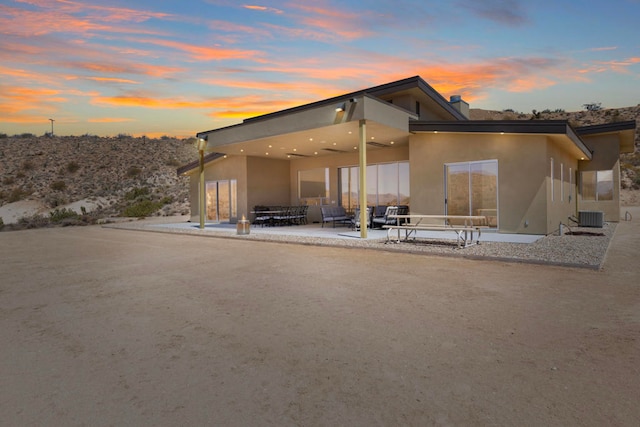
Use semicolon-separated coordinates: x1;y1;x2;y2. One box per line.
0;208;640;426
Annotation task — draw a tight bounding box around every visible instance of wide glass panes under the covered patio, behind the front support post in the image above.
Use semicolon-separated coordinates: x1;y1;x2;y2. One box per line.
338;162;410;210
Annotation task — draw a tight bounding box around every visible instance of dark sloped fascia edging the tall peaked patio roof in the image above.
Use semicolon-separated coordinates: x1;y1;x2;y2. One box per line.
196;76;468;138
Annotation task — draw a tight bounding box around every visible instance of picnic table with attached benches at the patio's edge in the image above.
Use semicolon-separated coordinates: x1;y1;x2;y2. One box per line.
383;215;487;248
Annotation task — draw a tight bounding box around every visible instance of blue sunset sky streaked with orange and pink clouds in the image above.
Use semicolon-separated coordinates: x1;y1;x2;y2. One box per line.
0;0;640;137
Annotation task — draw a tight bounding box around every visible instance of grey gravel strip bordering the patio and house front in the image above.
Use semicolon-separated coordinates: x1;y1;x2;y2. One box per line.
104;221;616;269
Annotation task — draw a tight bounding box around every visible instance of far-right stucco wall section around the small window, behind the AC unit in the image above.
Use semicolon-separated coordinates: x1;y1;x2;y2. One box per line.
578;135;620;222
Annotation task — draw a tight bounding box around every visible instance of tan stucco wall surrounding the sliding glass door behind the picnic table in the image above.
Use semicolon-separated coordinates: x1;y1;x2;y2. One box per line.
410;133;549;234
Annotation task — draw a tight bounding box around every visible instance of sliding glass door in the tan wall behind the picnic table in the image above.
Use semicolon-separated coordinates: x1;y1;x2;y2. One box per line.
445;160;498;227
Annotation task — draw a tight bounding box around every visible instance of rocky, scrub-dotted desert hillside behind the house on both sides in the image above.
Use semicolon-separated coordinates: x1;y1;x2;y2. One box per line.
0;105;640;229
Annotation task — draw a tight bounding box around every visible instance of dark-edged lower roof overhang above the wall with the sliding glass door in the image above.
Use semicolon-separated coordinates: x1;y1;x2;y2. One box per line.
409;120;592;160
